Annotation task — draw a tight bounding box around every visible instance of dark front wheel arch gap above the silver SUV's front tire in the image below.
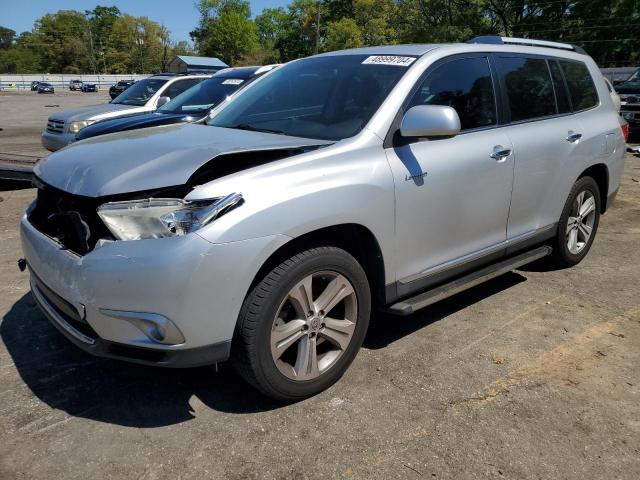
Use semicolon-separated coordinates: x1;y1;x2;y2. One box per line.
247;223;385;305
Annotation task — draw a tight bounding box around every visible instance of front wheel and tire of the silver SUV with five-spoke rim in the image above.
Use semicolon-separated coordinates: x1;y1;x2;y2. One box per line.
232;246;371;402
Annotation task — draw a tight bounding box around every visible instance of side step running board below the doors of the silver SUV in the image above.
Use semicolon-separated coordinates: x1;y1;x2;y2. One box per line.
388;246;552;315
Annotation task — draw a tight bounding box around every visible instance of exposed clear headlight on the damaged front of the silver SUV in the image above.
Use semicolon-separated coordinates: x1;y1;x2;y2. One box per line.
98;193;242;240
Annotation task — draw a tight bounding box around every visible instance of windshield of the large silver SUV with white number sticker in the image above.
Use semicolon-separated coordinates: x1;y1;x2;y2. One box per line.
208;55;415;140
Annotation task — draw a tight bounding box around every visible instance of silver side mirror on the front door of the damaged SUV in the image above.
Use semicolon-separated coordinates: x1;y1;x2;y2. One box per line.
400;105;460;138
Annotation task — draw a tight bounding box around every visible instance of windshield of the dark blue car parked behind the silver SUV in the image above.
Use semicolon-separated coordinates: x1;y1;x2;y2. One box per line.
158;77;249;114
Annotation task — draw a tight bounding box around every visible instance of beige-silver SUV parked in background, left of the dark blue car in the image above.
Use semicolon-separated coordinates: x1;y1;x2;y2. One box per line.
42;74;211;152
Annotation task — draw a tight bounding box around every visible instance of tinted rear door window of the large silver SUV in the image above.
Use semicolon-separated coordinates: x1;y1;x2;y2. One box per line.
498;57;556;122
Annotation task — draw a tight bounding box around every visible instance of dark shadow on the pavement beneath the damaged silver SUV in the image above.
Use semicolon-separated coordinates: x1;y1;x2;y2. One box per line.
0;273;525;428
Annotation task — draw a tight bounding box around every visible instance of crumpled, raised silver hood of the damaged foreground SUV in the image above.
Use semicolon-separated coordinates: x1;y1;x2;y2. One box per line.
34;124;332;197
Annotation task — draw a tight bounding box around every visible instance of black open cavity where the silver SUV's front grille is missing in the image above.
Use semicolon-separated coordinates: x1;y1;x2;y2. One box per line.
29;185;114;255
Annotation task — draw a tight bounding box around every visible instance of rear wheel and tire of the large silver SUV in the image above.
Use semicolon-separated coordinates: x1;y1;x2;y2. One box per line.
551;177;601;268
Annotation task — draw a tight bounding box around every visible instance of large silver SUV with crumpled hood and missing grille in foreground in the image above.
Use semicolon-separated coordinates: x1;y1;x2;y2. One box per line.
21;37;625;401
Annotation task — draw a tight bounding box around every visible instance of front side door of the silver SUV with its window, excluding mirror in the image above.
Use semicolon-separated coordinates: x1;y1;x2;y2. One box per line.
386;54;513;295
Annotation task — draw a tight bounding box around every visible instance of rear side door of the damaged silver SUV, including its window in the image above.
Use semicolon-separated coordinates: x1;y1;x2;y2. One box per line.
495;54;584;243
